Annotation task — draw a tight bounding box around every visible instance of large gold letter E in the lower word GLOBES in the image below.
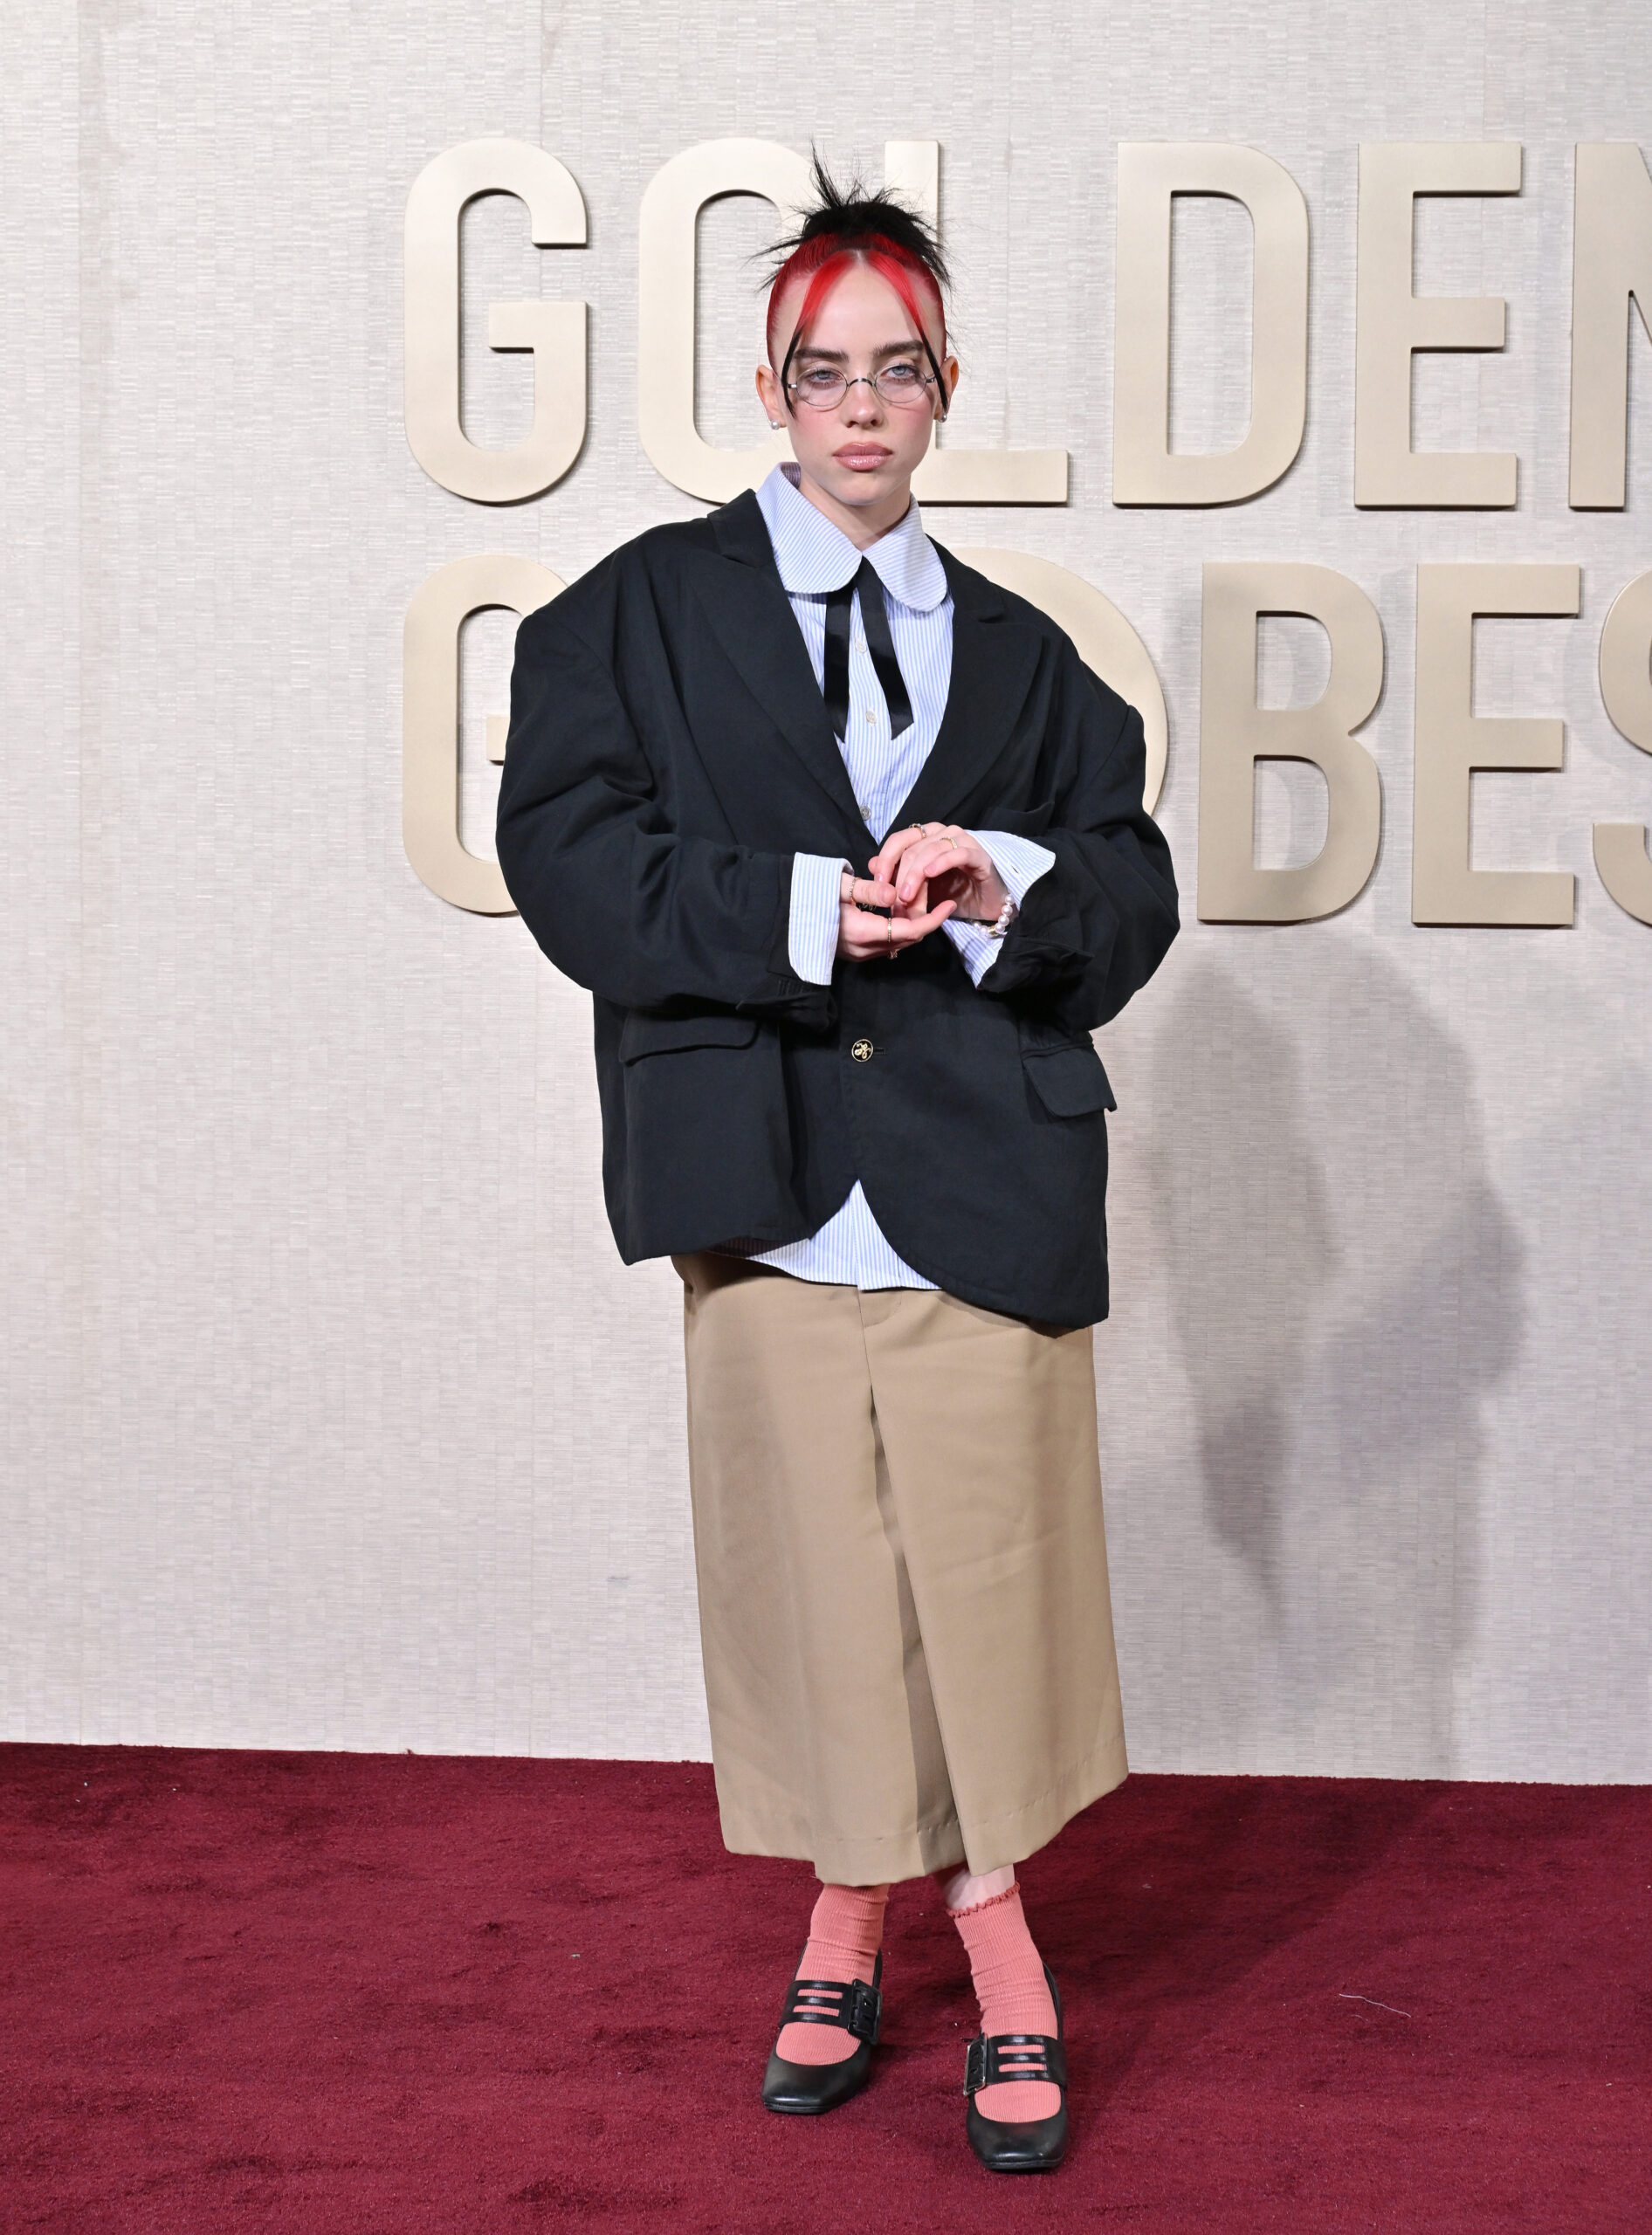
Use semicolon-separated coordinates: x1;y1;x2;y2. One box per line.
1410;566;1579;925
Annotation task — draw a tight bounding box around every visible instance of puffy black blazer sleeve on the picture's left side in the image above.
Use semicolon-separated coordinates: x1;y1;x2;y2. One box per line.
499;592;831;1023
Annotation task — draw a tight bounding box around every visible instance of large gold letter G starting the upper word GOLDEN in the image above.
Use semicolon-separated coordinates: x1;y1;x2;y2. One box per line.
403;141;586;505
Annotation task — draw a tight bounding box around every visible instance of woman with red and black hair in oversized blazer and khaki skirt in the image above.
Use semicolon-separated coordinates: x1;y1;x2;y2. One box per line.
499;165;1176;2172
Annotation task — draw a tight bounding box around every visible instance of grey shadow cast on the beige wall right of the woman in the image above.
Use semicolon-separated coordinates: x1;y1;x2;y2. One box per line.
1153;932;1523;1775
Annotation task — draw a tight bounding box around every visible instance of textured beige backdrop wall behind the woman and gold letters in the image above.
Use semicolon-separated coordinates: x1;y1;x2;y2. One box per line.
0;0;1652;1779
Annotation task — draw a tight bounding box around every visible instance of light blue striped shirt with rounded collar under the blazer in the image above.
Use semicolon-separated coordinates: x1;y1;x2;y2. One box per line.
751;463;1055;1288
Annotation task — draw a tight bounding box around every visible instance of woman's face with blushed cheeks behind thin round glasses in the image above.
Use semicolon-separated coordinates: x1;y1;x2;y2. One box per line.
758;264;957;526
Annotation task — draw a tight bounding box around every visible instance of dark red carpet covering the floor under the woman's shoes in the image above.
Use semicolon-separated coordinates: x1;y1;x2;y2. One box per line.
0;1745;1652;2235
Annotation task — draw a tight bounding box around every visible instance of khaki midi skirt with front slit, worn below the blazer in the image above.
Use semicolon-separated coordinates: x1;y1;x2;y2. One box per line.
675;1252;1125;1887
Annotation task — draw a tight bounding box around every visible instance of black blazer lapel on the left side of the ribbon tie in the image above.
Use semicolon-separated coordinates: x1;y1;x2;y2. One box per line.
695;490;863;831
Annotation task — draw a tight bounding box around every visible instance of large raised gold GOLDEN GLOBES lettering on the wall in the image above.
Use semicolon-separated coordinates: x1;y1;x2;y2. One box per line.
403;139;1652;925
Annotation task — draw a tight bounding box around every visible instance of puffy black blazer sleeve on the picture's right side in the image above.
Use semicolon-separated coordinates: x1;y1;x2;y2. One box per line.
979;643;1180;1033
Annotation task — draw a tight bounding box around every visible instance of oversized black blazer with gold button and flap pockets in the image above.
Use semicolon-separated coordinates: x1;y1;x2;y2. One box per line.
499;494;1176;1325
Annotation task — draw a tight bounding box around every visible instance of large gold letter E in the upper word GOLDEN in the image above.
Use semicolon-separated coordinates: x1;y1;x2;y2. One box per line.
1354;141;1520;507
